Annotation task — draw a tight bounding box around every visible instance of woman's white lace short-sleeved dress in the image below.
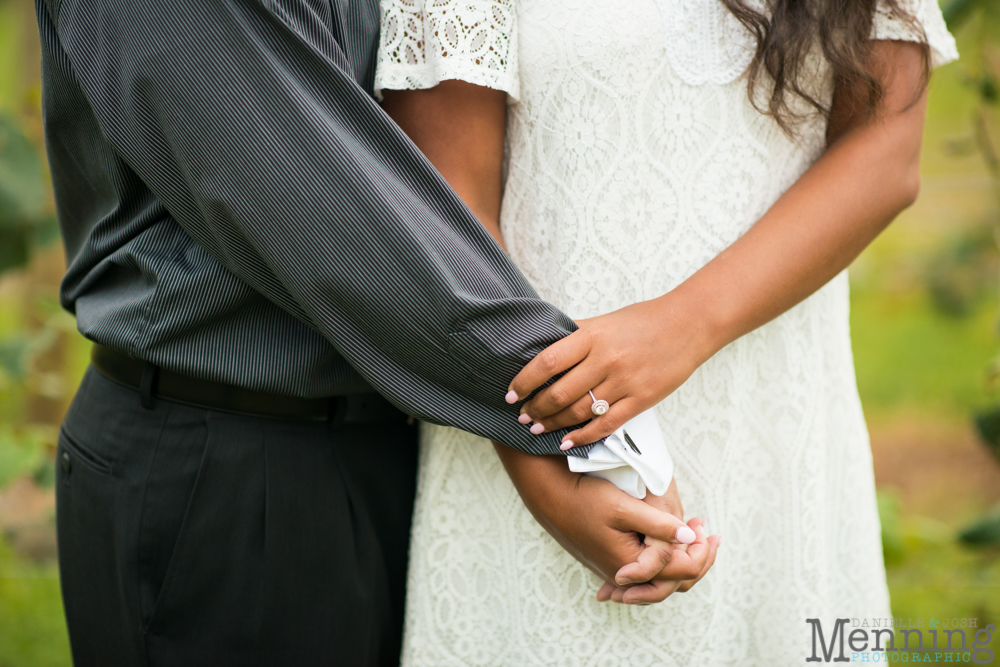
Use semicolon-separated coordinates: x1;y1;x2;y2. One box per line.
377;0;957;667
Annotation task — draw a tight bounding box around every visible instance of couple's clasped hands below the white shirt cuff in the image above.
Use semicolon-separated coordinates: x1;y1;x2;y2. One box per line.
494;443;714;604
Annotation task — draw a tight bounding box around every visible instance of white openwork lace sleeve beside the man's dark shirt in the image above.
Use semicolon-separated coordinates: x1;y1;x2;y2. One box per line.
375;0;520;99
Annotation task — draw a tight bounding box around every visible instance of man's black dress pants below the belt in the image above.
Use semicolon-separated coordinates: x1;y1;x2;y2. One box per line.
57;368;417;667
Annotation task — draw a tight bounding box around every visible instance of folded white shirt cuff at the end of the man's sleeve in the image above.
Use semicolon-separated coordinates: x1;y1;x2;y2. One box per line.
566;410;674;499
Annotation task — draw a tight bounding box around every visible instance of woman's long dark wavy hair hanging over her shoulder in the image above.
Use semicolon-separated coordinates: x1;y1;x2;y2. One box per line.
722;0;930;132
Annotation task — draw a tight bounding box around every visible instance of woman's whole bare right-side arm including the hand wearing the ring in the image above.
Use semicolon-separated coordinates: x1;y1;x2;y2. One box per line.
507;41;927;448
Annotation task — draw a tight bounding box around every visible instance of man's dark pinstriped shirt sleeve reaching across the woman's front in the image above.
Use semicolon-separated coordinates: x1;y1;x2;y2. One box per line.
45;0;583;455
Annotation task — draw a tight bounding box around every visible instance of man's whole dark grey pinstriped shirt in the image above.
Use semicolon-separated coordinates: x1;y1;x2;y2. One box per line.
36;0;583;455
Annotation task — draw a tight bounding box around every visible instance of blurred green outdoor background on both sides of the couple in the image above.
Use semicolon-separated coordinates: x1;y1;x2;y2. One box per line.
0;0;1000;667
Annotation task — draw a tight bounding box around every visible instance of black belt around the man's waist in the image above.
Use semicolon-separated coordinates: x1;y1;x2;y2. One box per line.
90;345;406;423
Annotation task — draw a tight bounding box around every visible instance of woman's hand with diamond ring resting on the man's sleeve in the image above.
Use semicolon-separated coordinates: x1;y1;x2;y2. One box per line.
511;292;717;449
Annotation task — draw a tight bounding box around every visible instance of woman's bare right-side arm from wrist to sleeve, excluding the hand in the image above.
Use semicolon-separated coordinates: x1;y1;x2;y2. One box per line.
663;44;926;358
